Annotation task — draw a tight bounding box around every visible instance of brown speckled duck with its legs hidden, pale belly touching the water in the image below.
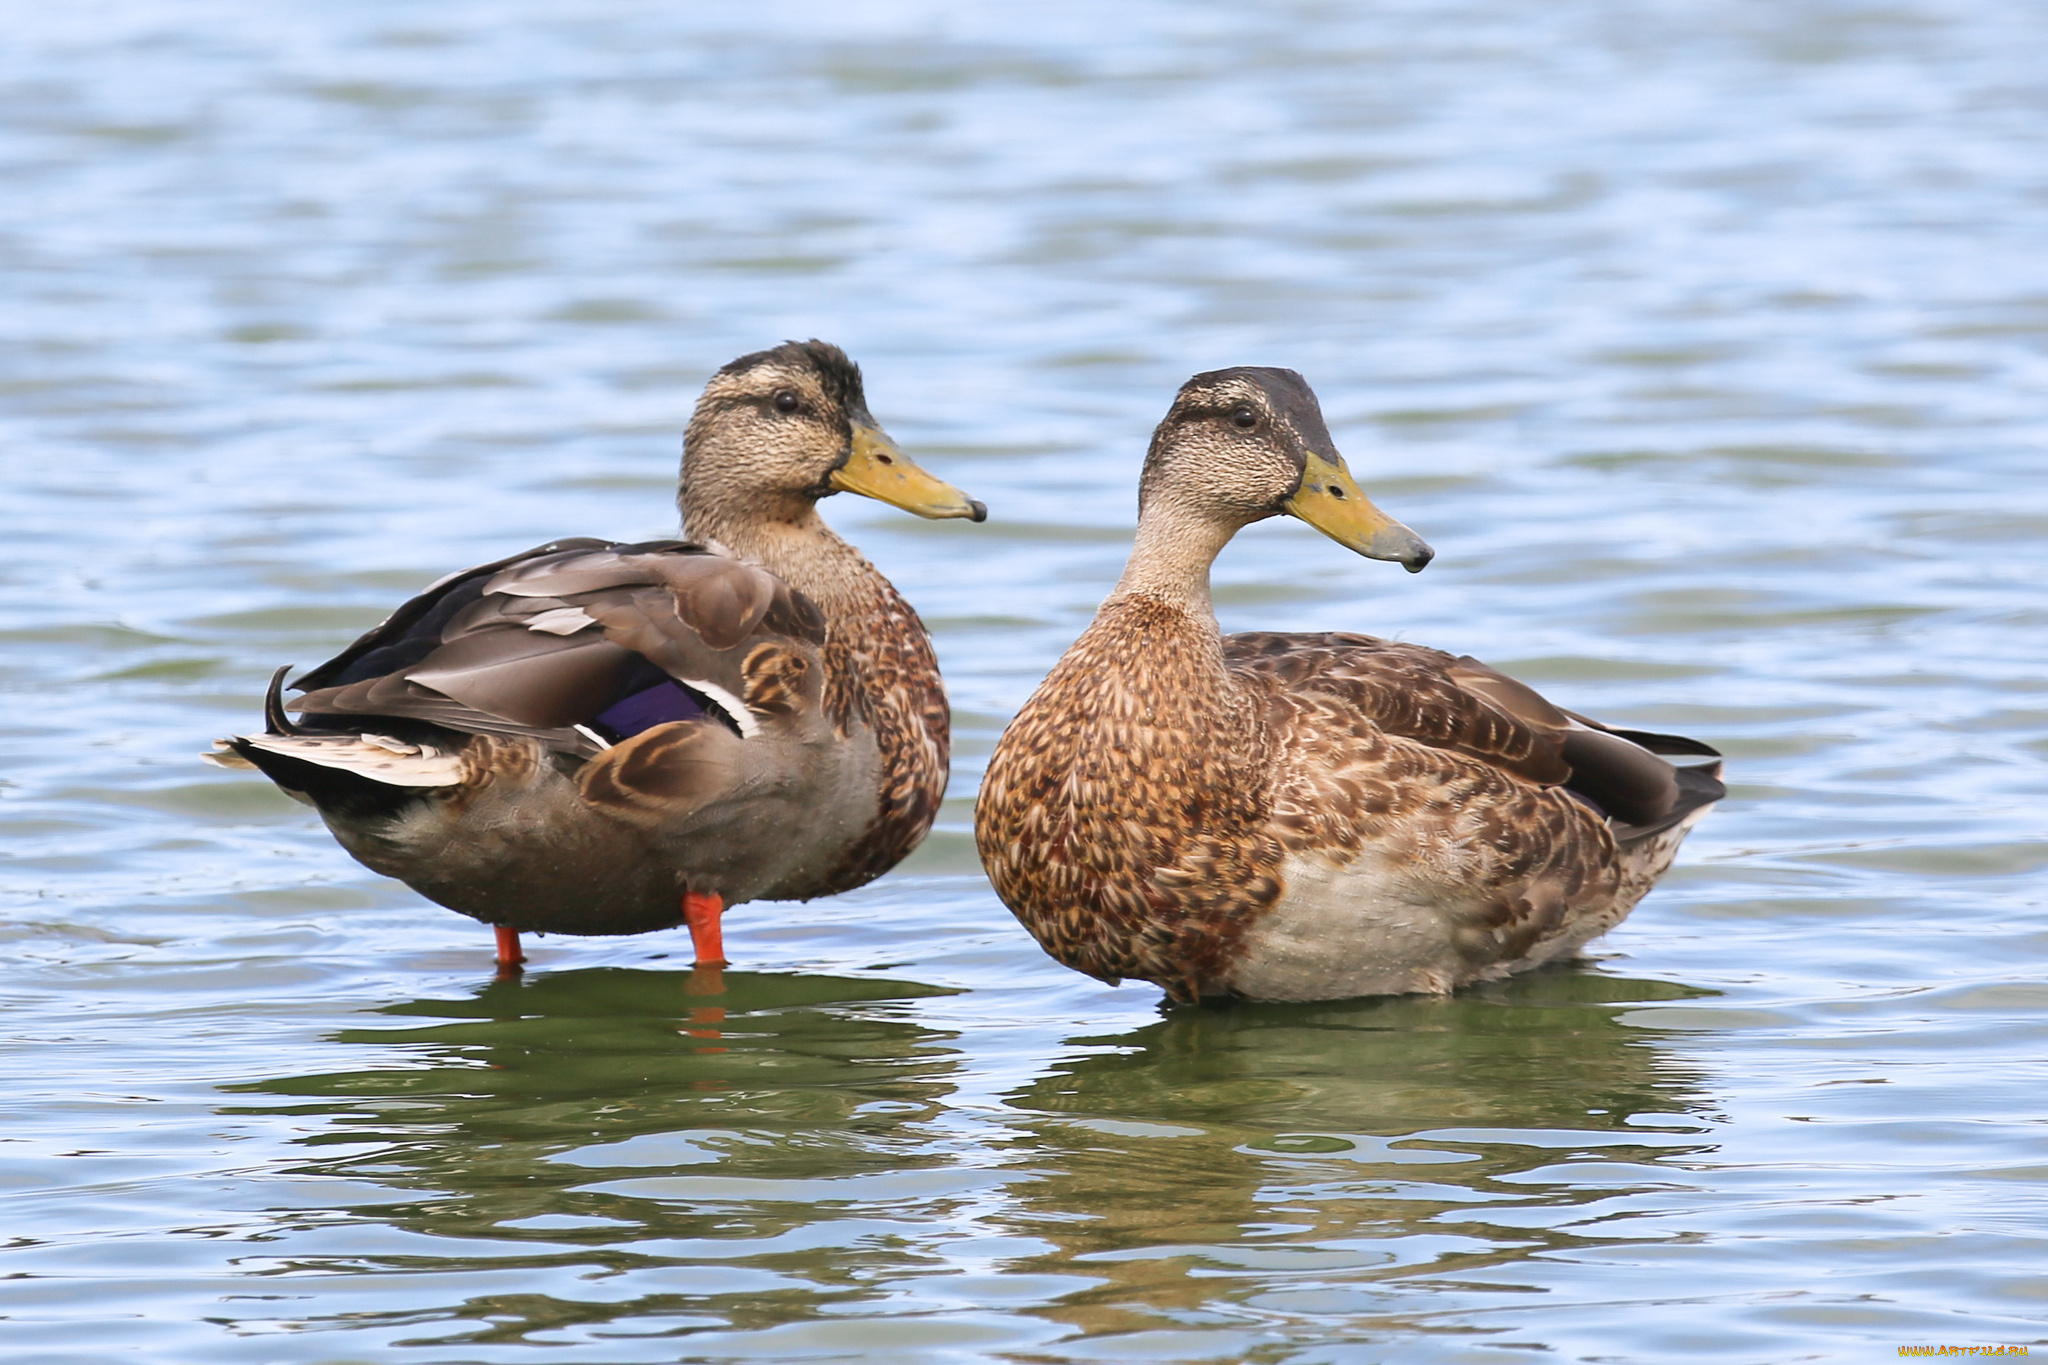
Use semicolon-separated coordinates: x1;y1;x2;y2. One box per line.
975;368;1722;1001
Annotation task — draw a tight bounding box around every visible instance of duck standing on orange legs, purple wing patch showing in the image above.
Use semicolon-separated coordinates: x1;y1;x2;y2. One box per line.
215;342;987;968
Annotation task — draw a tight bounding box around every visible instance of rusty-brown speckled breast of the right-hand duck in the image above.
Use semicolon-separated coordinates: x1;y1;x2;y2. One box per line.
975;598;1282;990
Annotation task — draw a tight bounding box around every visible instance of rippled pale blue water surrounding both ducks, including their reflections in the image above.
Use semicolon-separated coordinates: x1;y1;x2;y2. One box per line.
0;0;2048;1365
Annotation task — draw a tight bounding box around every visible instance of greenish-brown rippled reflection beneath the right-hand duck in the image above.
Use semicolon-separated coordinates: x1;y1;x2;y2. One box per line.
987;970;1714;1359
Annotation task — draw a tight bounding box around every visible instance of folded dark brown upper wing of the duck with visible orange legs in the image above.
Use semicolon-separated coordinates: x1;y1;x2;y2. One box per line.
299;540;825;755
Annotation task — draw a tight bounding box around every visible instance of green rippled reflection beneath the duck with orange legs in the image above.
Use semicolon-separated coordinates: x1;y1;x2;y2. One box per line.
227;968;961;1347
